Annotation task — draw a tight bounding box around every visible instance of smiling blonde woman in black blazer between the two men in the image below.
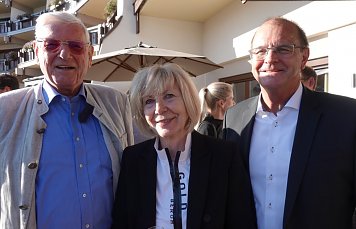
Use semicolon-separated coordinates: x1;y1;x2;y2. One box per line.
113;64;255;229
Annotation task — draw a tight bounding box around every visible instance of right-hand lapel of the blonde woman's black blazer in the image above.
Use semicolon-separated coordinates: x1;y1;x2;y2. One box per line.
187;131;210;229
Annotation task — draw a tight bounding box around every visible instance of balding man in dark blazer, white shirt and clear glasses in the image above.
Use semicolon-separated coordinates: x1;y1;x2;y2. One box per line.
224;18;356;229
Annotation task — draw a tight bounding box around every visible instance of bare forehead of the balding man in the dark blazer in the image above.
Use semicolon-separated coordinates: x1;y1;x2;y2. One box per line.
251;21;300;47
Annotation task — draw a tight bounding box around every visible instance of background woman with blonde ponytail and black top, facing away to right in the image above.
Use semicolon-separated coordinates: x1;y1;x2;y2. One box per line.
197;82;235;138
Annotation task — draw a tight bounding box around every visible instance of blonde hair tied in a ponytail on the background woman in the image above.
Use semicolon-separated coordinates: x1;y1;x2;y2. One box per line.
199;82;233;123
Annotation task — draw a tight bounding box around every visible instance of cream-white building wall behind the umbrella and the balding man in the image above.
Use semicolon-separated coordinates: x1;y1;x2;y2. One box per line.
98;1;356;96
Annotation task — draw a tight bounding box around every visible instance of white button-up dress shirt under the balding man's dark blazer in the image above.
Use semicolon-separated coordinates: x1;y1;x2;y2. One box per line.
249;84;303;229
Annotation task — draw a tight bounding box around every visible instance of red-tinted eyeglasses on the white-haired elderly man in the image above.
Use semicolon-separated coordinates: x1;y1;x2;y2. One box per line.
36;39;90;55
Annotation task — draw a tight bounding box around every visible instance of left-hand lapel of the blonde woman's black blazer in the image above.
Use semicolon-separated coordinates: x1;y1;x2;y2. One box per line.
137;142;157;228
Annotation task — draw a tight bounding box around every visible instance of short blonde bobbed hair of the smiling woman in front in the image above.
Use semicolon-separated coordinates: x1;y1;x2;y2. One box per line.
130;63;200;136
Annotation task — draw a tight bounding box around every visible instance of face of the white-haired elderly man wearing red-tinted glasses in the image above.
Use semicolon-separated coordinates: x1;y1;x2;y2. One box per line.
35;22;93;96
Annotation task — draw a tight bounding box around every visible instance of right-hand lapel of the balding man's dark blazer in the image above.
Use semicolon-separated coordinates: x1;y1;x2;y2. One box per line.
283;89;321;227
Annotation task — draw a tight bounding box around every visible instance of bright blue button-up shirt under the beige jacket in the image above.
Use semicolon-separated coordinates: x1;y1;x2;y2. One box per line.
36;81;114;229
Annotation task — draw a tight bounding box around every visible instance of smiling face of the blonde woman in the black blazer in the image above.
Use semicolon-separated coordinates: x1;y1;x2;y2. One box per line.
143;84;188;140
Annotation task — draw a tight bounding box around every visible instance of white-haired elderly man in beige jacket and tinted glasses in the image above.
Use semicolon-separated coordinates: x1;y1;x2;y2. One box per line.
0;12;133;229
